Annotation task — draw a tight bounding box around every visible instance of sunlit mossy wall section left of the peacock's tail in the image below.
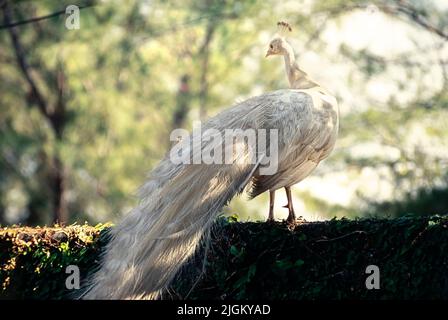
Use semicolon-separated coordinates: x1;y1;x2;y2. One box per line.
0;225;108;299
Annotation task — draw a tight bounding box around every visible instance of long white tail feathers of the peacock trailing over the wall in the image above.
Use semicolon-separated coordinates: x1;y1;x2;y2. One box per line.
82;132;261;299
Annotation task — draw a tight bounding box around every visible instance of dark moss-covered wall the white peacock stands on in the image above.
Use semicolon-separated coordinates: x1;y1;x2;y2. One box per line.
0;217;448;300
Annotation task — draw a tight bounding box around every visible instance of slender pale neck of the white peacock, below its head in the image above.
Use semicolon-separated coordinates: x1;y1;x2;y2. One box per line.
283;43;320;89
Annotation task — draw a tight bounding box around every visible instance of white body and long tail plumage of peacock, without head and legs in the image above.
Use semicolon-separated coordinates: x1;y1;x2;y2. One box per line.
83;21;338;299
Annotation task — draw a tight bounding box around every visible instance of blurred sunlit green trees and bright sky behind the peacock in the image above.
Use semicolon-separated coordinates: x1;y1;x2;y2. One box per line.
0;0;448;225
